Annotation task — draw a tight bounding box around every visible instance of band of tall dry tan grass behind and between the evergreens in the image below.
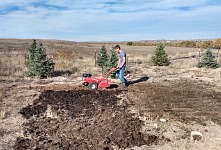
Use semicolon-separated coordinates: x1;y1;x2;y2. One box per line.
0;39;221;77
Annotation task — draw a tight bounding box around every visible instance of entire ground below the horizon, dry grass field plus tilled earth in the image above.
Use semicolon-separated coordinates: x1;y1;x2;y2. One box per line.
0;39;221;150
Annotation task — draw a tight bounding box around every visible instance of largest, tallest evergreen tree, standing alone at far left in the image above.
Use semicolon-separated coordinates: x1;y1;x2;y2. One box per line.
26;40;54;78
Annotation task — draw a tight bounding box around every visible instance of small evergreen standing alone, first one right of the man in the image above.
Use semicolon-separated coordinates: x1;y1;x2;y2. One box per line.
151;43;170;66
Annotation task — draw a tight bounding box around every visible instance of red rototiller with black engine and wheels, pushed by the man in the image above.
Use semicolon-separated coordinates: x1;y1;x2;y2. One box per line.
82;68;117;90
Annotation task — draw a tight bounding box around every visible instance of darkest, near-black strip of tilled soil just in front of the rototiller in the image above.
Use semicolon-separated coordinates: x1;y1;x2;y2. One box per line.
20;90;122;119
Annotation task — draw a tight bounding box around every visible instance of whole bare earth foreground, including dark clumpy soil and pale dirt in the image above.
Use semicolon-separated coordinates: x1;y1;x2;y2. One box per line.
0;78;221;150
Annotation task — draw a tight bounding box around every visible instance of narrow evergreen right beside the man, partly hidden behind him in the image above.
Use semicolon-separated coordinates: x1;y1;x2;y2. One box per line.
105;49;118;78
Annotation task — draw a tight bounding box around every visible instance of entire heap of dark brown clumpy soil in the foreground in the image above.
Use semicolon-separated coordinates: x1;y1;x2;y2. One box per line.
14;90;165;150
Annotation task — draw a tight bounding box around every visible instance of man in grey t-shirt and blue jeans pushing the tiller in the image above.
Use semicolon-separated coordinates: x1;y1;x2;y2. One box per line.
114;45;127;88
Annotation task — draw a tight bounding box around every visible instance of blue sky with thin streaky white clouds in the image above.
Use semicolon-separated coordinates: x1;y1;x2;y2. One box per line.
0;0;221;41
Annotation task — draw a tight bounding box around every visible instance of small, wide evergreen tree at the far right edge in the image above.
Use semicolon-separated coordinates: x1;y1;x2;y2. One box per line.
197;49;219;69
